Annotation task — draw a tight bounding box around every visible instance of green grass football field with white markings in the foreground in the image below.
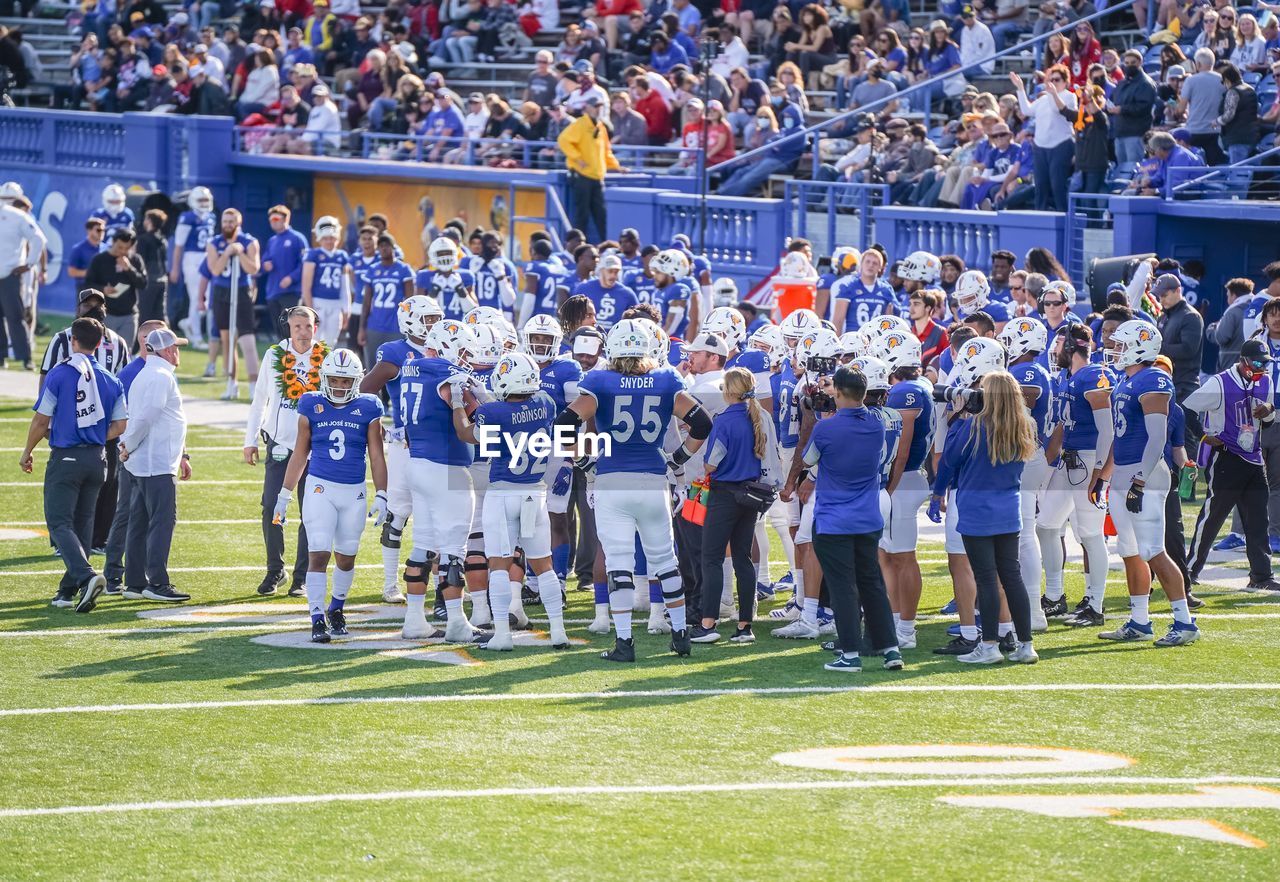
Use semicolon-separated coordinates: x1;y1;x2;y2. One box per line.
0;396;1280;881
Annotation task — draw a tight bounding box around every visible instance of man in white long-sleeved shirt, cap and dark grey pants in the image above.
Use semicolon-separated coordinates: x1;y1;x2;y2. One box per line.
120;328;191;603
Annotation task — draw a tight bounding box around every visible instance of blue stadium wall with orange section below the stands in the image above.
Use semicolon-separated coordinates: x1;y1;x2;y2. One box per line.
0;108;1280;319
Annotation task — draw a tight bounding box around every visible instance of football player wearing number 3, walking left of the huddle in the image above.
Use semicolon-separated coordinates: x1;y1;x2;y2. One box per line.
273;349;387;643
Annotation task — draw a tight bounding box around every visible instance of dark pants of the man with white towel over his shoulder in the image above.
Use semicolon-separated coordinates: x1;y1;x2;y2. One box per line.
45;447;106;593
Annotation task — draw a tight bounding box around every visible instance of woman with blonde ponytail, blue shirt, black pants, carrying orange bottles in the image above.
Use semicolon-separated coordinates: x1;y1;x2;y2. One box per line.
690;367;778;643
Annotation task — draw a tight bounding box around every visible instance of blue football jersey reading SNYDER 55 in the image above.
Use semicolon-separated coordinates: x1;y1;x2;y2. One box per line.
579;367;685;475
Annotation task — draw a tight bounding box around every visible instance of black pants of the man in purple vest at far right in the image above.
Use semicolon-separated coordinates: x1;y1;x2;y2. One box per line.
1189;448;1271;582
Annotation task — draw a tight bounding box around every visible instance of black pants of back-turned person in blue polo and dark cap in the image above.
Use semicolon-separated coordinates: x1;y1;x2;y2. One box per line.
813;530;896;655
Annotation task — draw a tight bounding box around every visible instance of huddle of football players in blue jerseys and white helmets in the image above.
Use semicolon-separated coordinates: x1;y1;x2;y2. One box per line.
275;218;1199;670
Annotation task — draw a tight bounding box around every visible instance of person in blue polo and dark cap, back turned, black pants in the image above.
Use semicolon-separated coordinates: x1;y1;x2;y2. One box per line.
798;367;902;672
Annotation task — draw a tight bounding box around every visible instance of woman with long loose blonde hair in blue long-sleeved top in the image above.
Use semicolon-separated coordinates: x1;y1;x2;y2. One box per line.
931;370;1038;664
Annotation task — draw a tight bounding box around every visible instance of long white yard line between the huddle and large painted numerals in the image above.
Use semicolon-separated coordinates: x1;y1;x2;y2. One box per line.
0;682;1280;717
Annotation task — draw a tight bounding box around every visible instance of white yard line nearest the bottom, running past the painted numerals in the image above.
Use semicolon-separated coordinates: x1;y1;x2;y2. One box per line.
0;774;1280;818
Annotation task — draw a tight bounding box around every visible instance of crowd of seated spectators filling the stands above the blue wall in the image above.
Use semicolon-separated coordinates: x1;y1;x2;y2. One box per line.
0;0;1280;200
